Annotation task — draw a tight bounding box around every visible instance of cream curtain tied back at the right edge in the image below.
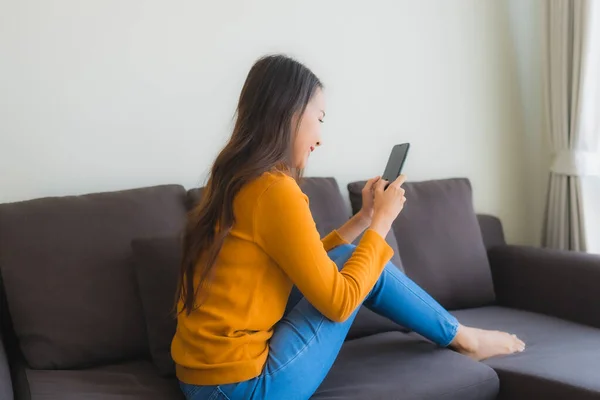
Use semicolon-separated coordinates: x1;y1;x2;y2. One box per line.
543;0;600;251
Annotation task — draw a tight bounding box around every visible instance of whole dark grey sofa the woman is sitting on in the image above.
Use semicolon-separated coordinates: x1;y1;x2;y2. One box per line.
0;178;600;400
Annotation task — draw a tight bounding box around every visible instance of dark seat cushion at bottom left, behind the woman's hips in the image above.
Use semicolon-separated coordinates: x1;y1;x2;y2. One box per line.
21;361;184;400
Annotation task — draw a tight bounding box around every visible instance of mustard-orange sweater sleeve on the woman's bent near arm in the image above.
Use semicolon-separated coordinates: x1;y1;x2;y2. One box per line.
254;178;393;322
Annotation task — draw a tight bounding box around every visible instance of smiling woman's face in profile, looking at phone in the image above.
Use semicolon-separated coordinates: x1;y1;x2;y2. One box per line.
292;88;325;169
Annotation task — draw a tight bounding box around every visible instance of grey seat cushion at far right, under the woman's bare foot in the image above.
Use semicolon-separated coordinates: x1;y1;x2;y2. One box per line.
453;306;600;400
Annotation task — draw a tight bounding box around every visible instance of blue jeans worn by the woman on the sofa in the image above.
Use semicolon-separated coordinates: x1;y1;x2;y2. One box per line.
180;245;458;400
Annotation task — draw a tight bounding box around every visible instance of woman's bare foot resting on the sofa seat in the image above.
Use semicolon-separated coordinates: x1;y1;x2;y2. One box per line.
450;325;525;361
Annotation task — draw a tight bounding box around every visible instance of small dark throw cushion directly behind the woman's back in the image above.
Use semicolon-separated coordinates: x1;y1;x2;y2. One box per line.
131;237;181;376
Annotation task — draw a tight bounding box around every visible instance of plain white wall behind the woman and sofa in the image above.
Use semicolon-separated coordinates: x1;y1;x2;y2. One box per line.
0;0;534;243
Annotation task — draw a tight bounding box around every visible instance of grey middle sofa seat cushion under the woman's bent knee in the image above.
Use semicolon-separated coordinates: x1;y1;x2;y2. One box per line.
313;332;499;400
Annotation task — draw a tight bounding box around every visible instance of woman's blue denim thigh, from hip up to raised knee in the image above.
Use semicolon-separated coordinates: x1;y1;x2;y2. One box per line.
182;246;358;400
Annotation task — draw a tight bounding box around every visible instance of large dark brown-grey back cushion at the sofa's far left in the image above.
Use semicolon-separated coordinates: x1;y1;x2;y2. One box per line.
0;185;185;369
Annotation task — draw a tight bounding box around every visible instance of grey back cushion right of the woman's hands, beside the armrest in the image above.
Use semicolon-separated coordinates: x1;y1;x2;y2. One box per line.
348;179;494;309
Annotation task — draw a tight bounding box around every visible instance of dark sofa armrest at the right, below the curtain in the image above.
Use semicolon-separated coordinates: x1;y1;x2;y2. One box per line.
488;246;600;328
